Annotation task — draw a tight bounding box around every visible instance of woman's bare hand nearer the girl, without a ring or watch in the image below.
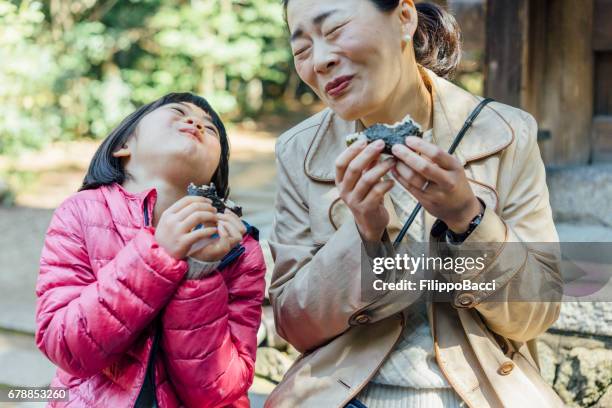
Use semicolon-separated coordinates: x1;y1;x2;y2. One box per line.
336;140;395;242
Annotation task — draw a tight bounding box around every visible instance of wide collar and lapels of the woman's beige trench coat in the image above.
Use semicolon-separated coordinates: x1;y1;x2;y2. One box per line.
304;70;514;182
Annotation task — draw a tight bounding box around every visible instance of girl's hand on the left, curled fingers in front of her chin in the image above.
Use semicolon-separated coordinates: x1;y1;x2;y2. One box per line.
155;196;218;259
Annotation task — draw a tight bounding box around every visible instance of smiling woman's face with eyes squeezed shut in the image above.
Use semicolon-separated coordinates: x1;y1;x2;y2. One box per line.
287;0;414;120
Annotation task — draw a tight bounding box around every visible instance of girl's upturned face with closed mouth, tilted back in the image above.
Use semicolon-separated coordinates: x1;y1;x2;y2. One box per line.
118;102;221;184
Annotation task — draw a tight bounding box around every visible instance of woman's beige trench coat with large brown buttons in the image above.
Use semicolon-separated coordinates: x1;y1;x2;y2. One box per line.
266;71;562;408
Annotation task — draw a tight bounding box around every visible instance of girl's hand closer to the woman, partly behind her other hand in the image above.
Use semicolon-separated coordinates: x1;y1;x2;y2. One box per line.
190;210;246;262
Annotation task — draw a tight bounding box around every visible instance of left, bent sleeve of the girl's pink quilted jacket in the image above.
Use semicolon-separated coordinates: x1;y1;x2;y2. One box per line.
36;199;187;378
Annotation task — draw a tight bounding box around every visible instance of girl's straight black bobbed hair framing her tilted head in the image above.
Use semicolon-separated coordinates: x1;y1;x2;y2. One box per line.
79;92;229;198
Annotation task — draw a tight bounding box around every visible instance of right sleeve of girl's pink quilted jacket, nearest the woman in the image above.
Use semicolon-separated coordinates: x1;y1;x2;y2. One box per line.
161;236;265;407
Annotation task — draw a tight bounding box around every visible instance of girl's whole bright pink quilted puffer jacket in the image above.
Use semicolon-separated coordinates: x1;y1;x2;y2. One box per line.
36;184;265;408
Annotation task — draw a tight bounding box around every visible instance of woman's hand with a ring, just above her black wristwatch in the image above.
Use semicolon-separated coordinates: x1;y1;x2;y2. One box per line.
392;136;481;234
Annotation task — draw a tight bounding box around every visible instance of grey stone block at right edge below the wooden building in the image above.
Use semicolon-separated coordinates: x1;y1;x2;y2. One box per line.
547;164;612;227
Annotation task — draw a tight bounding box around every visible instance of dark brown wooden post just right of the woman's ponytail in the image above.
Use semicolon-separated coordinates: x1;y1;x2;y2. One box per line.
485;0;527;106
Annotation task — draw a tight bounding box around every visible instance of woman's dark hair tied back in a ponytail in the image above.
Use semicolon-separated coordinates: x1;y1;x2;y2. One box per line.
282;0;461;79
